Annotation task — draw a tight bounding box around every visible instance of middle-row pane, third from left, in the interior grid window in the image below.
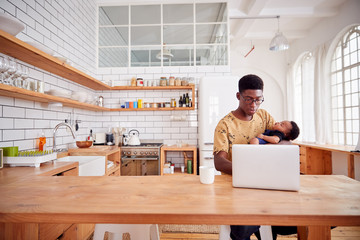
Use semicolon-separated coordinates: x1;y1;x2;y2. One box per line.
164;25;194;44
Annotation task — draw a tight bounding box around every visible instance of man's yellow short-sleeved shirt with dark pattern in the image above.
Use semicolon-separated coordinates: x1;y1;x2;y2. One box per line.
213;109;275;161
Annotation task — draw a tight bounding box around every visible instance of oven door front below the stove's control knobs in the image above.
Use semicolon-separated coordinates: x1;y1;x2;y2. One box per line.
121;156;160;176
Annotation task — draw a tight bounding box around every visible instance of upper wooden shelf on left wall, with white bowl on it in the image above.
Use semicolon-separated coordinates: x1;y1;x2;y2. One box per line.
0;30;111;90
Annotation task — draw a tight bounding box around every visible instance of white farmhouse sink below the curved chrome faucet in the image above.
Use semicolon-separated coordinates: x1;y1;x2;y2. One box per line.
56;156;105;176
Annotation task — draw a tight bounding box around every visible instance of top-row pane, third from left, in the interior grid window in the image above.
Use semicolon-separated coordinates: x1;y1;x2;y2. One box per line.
163;4;194;23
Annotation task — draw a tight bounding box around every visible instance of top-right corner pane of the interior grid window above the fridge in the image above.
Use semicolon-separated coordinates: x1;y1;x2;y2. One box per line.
195;3;227;23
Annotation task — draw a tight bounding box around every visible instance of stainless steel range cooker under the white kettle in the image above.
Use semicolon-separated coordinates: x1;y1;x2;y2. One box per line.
121;142;163;176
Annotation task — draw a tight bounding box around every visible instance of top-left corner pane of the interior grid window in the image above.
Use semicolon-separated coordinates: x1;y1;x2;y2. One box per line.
99;6;129;25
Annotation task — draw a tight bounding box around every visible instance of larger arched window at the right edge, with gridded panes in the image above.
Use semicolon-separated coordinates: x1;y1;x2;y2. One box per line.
330;26;360;145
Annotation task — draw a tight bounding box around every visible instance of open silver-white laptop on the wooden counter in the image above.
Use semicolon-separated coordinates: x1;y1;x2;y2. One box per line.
232;144;300;191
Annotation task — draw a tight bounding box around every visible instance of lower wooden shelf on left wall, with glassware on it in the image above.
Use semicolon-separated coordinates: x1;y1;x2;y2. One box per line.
0;83;110;111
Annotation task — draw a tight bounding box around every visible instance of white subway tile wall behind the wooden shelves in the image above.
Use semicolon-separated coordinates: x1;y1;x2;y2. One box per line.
0;0;230;167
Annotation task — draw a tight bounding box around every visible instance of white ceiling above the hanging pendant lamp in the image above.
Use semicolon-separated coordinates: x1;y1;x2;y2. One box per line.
228;0;346;42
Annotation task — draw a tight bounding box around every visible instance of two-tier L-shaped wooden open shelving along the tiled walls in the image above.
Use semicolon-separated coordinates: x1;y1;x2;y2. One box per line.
0;30;195;111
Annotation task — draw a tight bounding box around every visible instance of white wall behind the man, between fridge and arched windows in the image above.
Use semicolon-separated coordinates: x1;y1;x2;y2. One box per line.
230;39;288;121
